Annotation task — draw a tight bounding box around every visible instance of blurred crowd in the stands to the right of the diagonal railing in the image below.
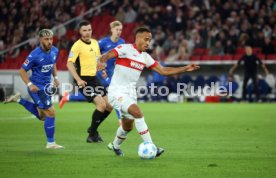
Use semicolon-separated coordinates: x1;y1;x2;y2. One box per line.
106;0;276;61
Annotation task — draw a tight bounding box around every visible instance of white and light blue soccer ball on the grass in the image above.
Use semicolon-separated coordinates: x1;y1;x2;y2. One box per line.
138;142;157;159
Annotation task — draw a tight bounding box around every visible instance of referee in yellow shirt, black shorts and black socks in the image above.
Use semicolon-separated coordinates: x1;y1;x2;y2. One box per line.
67;21;112;143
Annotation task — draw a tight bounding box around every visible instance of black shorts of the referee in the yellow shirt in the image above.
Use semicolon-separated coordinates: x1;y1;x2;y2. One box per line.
79;76;107;103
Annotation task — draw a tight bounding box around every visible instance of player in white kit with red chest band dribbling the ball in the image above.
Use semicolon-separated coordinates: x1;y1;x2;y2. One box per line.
98;27;199;157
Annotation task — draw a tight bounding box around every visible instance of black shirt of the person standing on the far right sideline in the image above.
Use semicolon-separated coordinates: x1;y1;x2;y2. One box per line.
238;54;263;74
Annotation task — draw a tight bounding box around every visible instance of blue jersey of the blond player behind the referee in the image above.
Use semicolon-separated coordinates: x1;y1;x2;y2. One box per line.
98;36;125;78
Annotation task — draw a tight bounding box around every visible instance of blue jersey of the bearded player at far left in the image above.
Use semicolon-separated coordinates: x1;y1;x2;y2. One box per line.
22;46;58;89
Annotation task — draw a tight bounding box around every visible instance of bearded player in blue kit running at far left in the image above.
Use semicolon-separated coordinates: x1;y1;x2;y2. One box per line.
4;29;63;149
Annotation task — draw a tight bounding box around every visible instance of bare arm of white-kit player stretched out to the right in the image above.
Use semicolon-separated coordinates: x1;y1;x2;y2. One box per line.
153;64;200;75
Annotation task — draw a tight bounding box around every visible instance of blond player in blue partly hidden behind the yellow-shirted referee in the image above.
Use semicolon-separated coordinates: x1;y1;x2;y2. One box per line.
59;21;125;124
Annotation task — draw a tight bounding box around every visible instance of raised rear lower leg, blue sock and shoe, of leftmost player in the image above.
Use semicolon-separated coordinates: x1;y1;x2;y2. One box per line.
4;93;41;119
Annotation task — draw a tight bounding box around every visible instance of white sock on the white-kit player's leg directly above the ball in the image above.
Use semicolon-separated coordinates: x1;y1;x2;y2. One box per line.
135;117;152;143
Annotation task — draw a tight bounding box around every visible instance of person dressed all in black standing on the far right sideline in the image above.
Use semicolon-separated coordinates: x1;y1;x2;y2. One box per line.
229;46;269;100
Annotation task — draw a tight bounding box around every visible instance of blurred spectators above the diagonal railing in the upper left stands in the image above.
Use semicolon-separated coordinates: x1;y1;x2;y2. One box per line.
0;0;104;57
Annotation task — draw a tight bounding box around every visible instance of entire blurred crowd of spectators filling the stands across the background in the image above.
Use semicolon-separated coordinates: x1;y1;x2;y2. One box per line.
0;0;276;61
